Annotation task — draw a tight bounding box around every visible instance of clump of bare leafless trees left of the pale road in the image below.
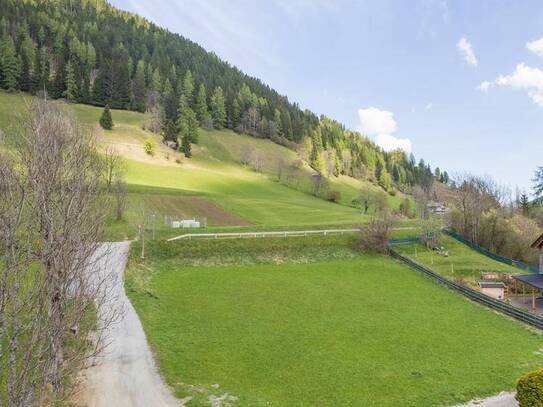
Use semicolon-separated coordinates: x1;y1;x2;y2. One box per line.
0;101;118;406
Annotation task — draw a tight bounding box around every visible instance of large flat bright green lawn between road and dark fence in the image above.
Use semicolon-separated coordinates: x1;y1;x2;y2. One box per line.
126;256;543;407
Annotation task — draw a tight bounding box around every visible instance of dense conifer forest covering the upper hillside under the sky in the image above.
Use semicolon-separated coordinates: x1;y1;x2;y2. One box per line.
0;0;448;190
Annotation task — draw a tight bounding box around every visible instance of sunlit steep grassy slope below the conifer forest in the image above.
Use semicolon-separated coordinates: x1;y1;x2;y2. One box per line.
0;93;406;237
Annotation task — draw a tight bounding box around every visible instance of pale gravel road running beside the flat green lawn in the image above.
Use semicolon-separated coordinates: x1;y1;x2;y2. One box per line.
80;242;182;407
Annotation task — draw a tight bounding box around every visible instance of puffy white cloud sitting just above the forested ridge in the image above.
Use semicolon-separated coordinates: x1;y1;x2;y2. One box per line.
358;107;411;153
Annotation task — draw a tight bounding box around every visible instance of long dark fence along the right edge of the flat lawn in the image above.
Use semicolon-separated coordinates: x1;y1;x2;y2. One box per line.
389;246;543;330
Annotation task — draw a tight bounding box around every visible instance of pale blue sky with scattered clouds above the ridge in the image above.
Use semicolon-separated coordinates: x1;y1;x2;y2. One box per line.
110;0;543;193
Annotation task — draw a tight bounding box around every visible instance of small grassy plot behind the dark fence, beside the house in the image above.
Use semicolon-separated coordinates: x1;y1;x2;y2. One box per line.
396;235;521;287
